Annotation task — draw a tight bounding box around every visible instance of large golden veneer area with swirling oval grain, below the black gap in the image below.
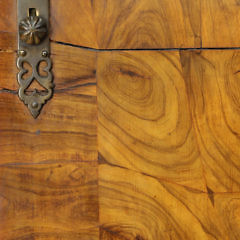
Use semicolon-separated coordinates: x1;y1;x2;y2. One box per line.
97;50;240;240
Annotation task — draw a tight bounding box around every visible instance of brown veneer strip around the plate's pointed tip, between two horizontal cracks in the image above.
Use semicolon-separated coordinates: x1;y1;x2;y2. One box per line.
0;93;97;164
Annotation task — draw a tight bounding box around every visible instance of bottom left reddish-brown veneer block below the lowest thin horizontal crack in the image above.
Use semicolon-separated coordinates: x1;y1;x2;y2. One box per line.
0;162;99;240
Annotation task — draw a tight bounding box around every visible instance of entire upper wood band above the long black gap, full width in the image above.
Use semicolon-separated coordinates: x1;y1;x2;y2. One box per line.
0;0;240;49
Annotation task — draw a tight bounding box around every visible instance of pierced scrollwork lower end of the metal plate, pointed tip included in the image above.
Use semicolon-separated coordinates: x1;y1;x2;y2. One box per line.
17;56;54;118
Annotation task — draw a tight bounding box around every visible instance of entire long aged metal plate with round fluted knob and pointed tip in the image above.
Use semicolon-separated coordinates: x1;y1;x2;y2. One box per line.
17;0;54;118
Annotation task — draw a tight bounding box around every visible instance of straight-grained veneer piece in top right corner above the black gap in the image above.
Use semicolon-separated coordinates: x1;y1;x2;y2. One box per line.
201;0;240;48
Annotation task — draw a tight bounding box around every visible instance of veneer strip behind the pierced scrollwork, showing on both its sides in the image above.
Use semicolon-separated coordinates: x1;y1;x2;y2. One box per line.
0;43;96;96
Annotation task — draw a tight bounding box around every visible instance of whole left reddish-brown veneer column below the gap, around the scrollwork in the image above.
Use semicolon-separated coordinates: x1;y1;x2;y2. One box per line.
0;44;99;240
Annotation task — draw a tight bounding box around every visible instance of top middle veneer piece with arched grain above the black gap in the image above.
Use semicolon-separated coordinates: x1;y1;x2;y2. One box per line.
94;0;201;49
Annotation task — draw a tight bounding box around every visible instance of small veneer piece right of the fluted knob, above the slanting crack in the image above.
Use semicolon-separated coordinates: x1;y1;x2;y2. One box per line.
50;0;98;48
